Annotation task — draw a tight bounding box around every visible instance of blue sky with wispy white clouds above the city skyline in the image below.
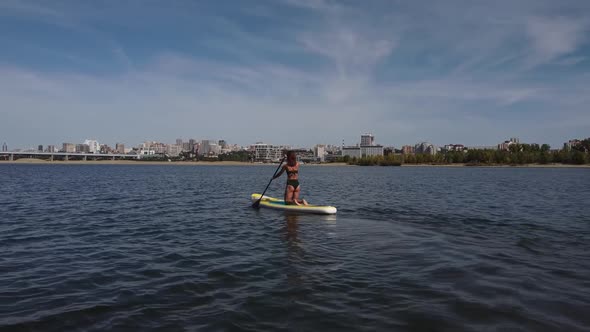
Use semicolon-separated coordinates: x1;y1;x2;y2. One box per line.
0;0;590;148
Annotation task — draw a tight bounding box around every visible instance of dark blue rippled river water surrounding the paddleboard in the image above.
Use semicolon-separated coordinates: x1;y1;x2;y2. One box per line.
0;165;590;331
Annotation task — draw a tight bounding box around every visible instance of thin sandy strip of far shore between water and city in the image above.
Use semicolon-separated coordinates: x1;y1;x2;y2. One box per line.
0;158;590;168
